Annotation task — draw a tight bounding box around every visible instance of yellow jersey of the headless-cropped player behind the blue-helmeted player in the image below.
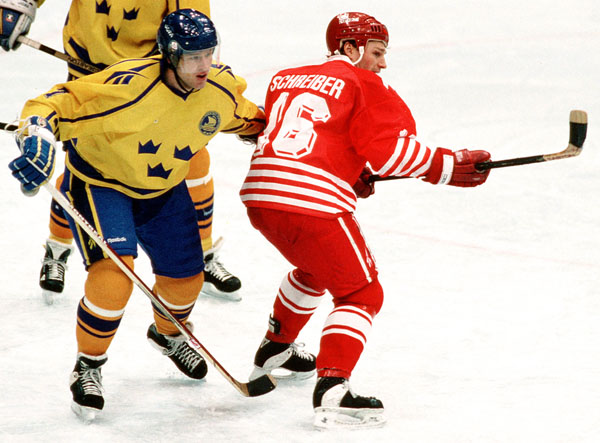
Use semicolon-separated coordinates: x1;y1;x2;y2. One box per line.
63;0;210;77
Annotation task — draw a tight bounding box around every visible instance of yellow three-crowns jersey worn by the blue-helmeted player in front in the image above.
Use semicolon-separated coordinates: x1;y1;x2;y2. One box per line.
22;56;265;198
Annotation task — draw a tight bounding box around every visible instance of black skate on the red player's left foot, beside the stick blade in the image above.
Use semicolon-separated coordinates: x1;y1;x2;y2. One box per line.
250;338;316;380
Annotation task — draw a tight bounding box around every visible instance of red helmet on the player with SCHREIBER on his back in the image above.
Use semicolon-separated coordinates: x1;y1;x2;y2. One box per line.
325;12;390;55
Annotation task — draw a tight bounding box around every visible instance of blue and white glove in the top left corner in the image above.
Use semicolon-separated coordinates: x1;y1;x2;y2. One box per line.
0;0;37;51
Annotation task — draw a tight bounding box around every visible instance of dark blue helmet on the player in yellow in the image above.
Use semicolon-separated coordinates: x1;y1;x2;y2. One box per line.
156;9;219;68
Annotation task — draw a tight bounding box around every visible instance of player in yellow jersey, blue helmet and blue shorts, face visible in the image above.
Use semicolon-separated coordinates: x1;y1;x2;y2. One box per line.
9;9;264;420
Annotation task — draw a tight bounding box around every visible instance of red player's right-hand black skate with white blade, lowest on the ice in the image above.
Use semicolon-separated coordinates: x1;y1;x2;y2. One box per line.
313;377;386;428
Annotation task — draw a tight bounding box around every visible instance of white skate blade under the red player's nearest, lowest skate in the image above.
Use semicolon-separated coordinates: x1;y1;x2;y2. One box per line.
313;407;387;429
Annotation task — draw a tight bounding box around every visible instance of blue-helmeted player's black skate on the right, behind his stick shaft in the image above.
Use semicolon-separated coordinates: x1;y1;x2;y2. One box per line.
146;322;208;380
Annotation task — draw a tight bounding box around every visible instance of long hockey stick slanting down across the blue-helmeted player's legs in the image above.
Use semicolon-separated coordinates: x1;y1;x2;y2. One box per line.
43;183;277;397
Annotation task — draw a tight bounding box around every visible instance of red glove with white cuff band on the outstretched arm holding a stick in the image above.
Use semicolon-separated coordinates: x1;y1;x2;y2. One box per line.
424;148;490;188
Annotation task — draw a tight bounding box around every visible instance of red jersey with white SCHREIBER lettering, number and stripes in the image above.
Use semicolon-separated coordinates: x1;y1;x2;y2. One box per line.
240;56;432;218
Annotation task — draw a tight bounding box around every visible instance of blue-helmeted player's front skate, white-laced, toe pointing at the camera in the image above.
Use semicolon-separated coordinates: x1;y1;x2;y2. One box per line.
69;352;107;422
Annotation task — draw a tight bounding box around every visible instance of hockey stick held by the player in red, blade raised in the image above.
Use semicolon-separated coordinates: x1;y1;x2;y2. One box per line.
369;110;587;183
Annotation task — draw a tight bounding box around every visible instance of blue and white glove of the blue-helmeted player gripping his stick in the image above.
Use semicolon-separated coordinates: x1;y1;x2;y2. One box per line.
8;116;56;195
